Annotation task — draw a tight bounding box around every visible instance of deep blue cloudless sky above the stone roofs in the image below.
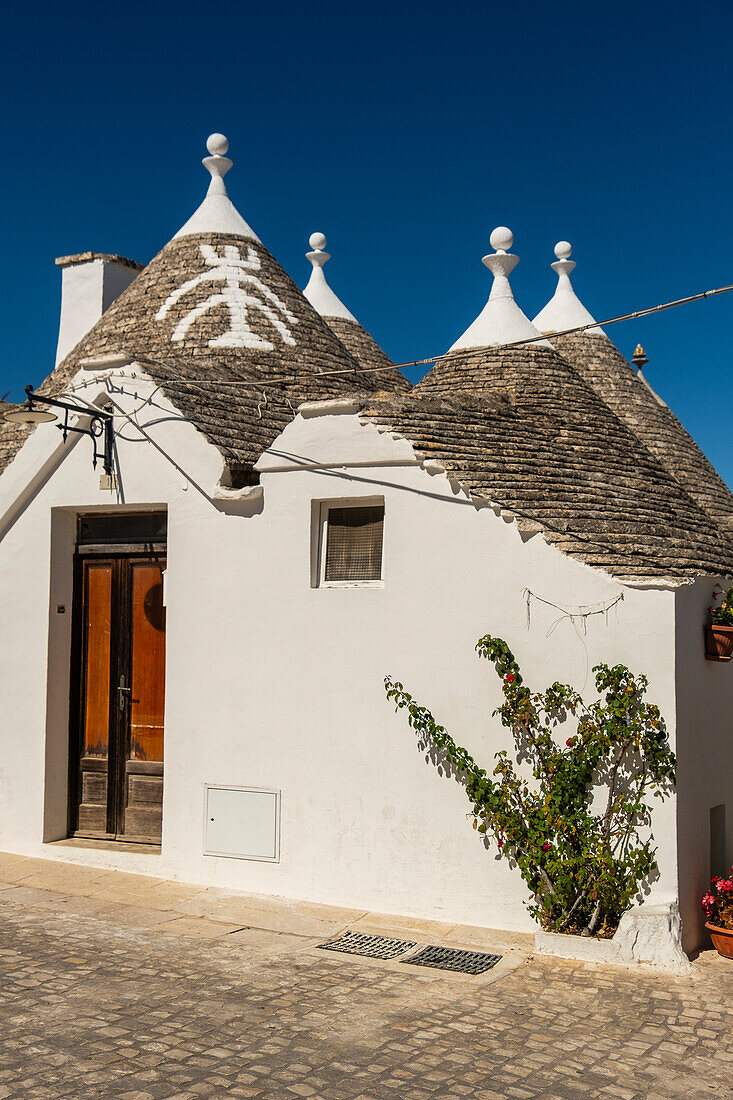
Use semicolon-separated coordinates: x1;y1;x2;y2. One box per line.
0;0;733;484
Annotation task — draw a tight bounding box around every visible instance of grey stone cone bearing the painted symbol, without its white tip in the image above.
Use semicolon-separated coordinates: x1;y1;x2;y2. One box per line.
51;232;365;388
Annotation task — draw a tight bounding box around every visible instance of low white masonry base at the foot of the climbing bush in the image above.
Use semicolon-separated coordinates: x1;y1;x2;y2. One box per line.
535;901;690;974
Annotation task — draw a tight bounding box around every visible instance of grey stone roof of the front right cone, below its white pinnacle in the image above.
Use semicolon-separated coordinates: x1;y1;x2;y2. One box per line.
394;228;733;579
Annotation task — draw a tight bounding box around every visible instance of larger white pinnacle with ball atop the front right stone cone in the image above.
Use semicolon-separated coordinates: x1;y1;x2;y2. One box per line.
450;226;550;351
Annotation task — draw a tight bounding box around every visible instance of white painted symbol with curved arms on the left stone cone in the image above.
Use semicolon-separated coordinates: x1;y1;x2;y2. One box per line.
155;244;298;351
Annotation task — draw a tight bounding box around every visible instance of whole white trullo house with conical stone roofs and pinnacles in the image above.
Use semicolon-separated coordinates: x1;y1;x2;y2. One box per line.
0;134;733;963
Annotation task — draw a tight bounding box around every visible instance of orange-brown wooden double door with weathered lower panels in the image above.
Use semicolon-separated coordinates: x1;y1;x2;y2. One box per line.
69;553;165;844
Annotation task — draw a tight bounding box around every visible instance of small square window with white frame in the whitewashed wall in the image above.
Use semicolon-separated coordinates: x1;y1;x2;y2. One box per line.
320;503;384;585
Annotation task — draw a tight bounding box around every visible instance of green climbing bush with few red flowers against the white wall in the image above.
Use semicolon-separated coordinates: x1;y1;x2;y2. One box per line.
385;635;675;936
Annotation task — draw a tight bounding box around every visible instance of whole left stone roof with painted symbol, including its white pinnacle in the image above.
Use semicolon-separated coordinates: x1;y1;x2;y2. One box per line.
0;134;409;479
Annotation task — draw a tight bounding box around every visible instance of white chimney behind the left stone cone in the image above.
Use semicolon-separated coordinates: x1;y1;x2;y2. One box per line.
56;252;142;366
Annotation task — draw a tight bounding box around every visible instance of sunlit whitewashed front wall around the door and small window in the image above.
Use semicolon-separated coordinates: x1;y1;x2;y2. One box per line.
0;382;677;931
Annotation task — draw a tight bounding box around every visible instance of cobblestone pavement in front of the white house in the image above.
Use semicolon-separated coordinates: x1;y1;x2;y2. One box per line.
0;883;733;1100
